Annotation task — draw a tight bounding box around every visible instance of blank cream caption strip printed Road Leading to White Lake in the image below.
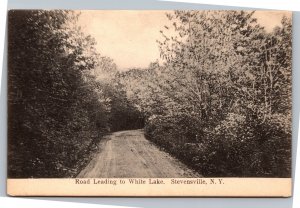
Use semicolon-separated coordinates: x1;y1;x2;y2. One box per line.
7;178;291;197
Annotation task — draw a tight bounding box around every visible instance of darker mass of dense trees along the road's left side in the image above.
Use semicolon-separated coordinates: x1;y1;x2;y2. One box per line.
8;10;142;177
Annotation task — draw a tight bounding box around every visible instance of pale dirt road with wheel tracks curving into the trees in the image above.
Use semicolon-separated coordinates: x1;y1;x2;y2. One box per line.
77;130;200;178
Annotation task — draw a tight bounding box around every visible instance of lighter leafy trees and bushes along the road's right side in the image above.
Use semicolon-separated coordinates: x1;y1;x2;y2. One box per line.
123;11;292;177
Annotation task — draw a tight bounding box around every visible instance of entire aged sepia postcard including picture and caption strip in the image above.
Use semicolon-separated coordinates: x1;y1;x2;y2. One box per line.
7;10;292;197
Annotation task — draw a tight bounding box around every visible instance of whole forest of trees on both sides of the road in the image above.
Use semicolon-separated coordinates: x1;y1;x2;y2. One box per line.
8;10;292;178
